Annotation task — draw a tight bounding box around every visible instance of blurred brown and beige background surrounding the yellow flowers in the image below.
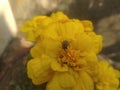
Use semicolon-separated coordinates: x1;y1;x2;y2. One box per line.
0;0;120;90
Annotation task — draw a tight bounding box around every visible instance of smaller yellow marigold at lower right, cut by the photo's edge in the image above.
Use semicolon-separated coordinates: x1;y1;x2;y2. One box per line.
94;60;120;90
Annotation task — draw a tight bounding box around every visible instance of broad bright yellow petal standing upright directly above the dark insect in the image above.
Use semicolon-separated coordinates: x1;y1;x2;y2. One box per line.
56;20;84;40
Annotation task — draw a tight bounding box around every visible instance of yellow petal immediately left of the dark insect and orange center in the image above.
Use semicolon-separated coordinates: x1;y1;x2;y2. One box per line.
30;38;61;58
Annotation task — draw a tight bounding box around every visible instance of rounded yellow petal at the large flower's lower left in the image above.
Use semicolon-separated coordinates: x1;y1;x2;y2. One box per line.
27;55;53;85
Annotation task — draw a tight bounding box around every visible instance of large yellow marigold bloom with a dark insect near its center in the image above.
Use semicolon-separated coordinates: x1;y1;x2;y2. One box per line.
22;12;118;90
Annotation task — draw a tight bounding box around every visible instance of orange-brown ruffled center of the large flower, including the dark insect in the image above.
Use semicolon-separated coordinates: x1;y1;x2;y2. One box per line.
58;40;84;70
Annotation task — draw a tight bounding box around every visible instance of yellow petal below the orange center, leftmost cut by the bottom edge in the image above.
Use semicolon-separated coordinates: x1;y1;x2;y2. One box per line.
46;72;76;90
